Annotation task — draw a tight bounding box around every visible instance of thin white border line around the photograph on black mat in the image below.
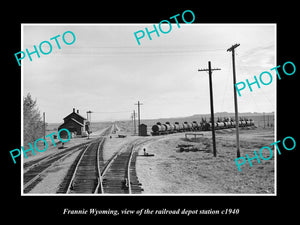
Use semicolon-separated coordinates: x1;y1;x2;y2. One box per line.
21;23;278;197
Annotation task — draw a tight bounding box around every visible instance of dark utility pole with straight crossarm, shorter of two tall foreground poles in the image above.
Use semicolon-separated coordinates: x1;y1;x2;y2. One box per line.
198;61;221;157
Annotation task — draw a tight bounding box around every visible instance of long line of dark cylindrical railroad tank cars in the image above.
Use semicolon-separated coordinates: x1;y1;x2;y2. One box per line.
151;118;254;136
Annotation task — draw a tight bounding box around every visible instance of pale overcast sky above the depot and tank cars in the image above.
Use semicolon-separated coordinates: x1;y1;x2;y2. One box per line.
22;23;276;123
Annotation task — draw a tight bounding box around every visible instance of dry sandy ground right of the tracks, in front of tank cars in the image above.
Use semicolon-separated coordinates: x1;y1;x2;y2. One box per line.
137;129;274;194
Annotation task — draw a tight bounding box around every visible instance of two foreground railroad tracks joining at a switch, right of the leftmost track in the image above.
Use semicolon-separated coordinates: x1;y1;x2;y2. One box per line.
63;137;149;194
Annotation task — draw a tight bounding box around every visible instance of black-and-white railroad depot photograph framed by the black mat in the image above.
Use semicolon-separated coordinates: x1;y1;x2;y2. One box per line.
18;23;276;196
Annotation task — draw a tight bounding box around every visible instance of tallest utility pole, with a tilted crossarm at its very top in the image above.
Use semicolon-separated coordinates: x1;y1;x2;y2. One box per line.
227;44;241;157
